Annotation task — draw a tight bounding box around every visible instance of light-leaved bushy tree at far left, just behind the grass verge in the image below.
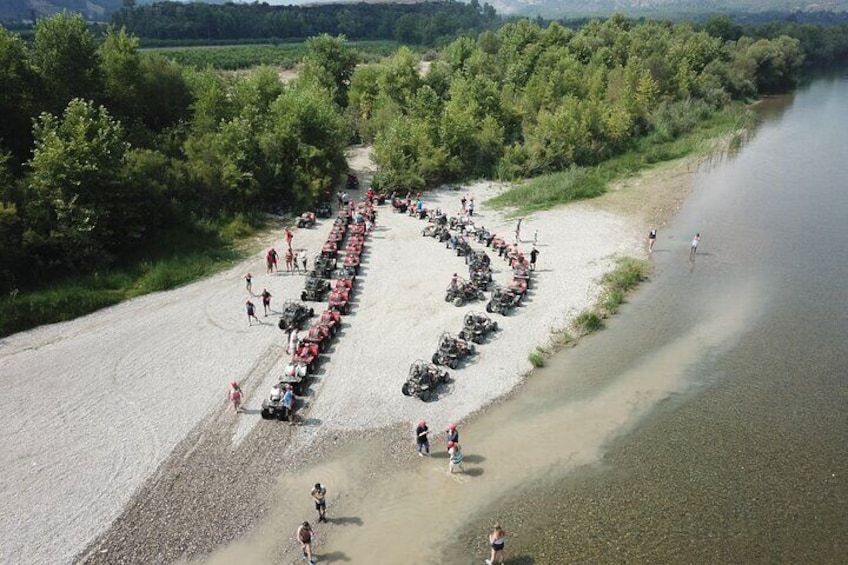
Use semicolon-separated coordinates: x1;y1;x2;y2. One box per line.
29;98;131;269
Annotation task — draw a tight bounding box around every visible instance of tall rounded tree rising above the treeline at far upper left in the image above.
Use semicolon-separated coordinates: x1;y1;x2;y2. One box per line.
32;12;102;113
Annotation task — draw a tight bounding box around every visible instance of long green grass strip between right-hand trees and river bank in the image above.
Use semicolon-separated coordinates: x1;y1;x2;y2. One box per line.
486;104;754;216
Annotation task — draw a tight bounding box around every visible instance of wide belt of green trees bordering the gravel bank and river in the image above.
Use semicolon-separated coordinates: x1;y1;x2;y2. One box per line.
0;9;848;330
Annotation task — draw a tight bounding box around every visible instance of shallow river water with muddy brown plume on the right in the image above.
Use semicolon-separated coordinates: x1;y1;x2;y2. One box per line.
205;74;848;565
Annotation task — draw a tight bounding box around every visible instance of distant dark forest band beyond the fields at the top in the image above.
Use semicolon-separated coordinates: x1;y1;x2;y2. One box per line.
113;0;500;45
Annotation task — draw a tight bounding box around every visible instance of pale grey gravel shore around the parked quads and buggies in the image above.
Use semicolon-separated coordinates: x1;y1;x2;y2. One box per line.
0;144;694;563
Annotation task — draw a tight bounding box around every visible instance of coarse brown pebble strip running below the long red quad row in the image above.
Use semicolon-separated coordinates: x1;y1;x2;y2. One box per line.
77;386;298;564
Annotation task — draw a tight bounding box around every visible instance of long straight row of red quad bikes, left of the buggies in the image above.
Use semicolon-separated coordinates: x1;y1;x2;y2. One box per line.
261;199;372;419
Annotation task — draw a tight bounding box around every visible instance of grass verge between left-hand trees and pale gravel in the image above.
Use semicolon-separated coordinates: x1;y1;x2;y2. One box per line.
0;216;263;337
